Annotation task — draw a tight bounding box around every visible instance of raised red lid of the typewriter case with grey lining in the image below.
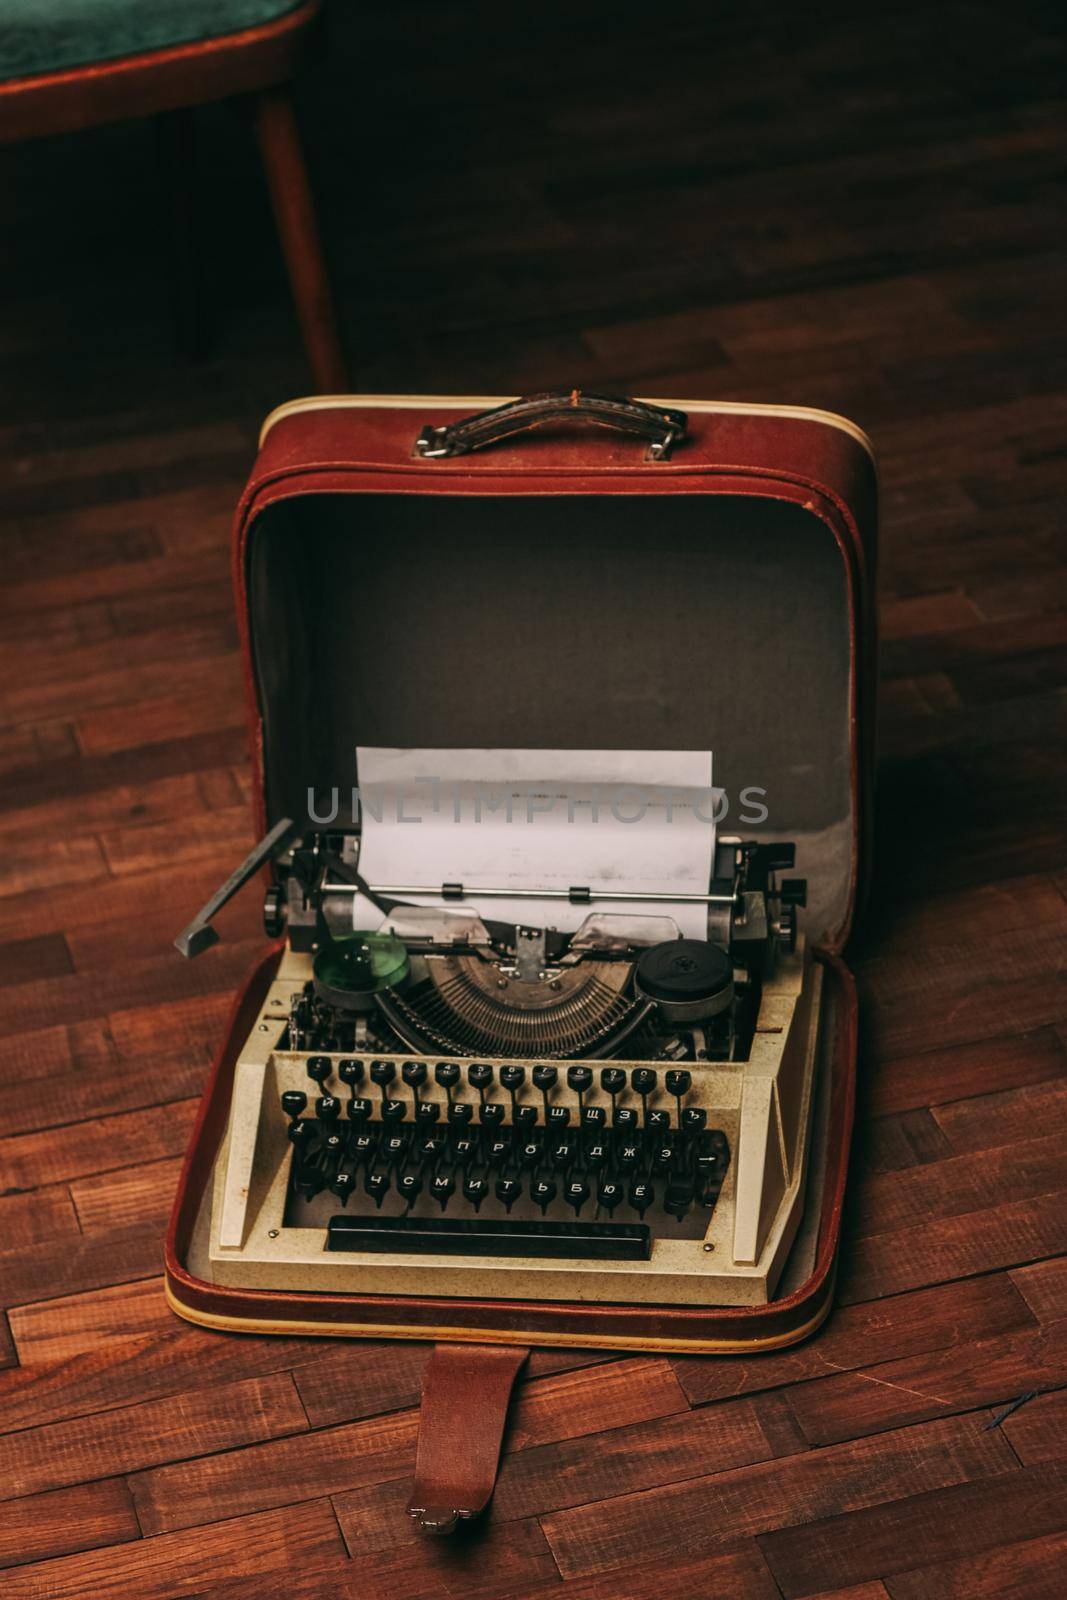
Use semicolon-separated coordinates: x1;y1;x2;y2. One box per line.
234;392;877;949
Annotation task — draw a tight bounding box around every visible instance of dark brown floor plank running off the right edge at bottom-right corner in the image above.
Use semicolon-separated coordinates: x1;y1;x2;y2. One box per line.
760;1467;1067;1600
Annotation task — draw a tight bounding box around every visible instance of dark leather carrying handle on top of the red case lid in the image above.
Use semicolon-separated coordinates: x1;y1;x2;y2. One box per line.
414;389;689;461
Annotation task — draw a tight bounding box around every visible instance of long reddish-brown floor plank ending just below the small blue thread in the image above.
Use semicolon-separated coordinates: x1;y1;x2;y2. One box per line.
542;1418;1017;1587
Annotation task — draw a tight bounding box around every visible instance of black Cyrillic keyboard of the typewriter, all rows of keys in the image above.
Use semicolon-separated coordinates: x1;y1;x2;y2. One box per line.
282;1056;729;1259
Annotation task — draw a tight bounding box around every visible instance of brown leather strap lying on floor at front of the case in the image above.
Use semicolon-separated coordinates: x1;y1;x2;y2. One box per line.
408;1344;530;1533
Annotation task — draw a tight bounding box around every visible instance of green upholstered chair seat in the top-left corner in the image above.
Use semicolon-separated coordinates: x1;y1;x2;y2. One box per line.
0;0;298;82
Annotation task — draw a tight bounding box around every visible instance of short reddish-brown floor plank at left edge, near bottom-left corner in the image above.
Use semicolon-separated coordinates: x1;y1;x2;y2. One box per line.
0;1478;141;1574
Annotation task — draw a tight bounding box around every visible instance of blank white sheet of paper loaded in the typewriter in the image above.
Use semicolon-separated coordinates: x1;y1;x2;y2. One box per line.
354;746;715;938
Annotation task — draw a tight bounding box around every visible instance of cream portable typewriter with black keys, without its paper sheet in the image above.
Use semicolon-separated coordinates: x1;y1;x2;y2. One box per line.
189;780;822;1306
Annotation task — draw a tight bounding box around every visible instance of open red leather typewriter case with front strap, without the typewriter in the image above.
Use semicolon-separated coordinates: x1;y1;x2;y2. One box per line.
166;390;877;1526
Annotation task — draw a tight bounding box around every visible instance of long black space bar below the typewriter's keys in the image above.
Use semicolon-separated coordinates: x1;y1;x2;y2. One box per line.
326;1216;651;1261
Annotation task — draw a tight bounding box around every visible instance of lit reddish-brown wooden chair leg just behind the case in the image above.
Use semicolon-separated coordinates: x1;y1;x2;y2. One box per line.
256;88;349;394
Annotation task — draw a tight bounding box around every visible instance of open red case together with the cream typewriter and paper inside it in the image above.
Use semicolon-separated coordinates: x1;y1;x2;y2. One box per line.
166;390;877;1522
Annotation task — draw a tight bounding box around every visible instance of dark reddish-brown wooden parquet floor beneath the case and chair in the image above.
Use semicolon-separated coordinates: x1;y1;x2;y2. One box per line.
0;0;1067;1600
